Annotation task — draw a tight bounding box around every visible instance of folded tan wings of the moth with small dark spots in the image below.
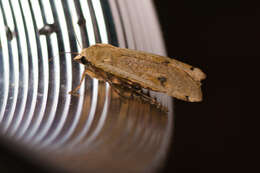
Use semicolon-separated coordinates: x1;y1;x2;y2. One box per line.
85;44;205;102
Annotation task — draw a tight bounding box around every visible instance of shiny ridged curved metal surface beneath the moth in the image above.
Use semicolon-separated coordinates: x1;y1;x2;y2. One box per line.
0;0;173;172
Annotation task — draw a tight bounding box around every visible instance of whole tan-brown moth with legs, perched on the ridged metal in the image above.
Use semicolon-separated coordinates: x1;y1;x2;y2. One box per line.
72;44;206;110
